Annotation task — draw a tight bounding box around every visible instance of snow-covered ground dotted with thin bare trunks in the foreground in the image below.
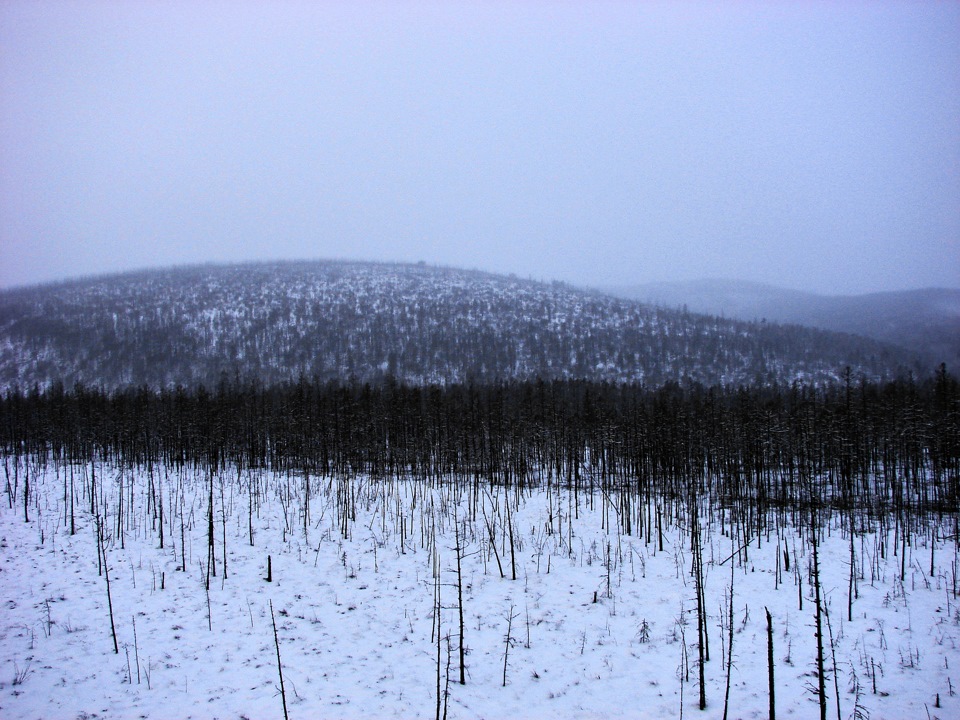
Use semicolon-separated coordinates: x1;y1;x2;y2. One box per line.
0;466;960;720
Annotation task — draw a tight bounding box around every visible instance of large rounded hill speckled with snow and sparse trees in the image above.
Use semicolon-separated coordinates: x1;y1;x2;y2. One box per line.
0;261;918;390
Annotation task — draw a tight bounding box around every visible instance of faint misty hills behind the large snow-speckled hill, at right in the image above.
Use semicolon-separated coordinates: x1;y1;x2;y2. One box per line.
605;279;960;368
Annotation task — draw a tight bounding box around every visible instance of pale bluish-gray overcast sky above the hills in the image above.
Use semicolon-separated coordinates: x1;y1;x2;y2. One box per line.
0;0;960;293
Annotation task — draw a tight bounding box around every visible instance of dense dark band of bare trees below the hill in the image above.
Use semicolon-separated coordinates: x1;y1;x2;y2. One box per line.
0;366;960;516
